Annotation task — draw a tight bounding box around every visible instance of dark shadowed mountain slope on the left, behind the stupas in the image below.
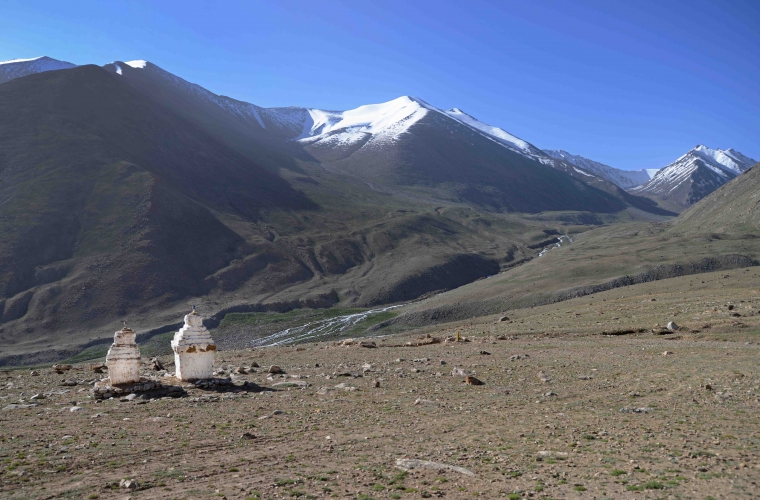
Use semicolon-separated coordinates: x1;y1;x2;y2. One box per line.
0;66;316;336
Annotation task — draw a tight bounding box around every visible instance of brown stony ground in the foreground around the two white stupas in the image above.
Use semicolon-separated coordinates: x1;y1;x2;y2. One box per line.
0;271;760;499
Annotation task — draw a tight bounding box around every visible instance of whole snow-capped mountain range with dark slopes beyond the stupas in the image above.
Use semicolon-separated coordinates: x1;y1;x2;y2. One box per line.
0;58;752;362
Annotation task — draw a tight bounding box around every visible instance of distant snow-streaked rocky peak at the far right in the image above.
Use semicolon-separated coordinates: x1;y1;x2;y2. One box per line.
631;145;757;208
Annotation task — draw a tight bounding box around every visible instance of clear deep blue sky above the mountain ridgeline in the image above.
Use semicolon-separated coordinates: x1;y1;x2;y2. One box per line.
0;0;760;169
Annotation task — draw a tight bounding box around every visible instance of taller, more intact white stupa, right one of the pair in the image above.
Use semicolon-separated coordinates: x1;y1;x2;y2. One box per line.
172;306;216;381
